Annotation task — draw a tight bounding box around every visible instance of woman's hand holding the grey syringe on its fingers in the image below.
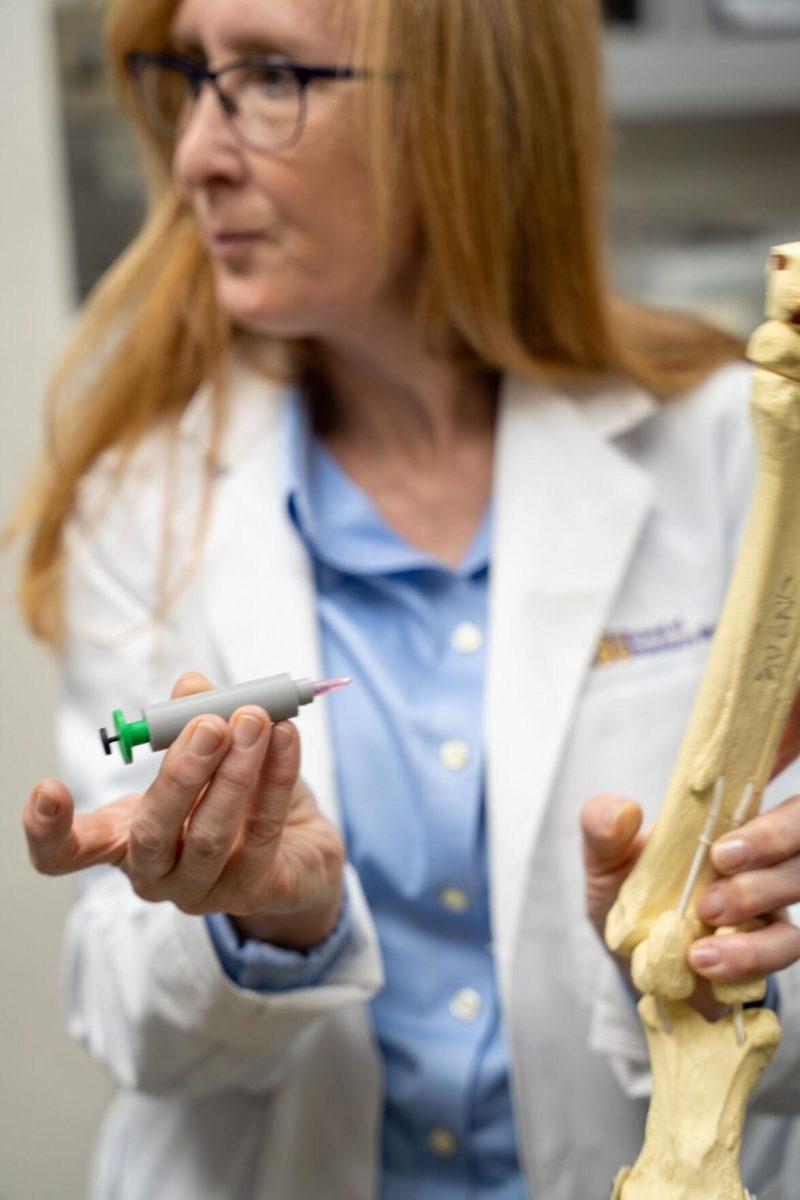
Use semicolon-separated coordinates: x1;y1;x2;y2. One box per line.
23;672;345;949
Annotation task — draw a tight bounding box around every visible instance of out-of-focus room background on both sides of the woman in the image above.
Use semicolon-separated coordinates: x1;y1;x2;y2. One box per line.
0;0;800;1200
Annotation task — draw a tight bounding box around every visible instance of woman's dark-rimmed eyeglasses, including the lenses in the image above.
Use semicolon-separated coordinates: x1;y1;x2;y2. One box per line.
125;50;372;150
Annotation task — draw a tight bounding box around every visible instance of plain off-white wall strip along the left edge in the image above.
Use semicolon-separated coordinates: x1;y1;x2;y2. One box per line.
0;0;115;1200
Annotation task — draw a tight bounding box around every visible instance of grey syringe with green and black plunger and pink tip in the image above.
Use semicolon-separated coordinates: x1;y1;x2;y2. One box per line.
100;674;350;763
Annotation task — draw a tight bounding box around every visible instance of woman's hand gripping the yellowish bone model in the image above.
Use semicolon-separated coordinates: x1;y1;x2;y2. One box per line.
581;697;800;1015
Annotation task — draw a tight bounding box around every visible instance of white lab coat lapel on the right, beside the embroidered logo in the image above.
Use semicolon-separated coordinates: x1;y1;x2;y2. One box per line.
487;376;654;984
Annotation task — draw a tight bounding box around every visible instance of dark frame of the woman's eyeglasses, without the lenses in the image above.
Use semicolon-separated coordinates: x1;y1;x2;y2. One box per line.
125;50;383;150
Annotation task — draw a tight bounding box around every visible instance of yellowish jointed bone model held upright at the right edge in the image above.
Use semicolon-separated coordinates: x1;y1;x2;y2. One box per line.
606;242;800;1200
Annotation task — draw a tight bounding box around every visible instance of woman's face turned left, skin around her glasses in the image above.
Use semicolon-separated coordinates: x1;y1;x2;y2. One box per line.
172;0;415;338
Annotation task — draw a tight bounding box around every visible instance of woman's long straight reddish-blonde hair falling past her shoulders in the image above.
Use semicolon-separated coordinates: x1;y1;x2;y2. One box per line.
11;0;742;642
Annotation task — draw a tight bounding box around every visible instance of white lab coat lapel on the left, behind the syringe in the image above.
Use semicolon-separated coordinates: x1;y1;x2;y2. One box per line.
196;371;339;823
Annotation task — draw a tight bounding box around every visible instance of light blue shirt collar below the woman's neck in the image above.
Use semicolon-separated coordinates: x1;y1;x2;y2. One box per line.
281;388;491;577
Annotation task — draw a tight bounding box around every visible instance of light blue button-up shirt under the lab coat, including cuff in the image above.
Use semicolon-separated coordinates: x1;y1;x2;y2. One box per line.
209;396;527;1200
